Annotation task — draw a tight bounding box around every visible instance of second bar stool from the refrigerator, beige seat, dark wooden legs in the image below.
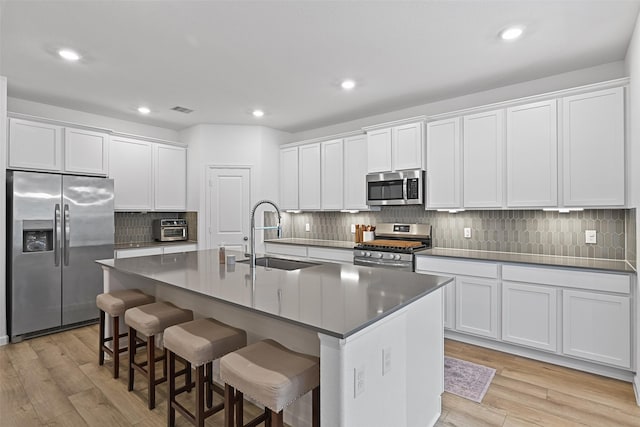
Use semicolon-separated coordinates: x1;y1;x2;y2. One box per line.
124;302;193;409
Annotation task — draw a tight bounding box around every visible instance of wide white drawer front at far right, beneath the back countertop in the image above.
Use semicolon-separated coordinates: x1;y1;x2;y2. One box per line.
502;265;631;294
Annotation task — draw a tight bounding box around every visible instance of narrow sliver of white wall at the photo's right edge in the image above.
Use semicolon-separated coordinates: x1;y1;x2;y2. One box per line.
625;10;640;404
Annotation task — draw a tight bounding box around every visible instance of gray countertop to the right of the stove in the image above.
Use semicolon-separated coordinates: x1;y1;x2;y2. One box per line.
417;248;636;273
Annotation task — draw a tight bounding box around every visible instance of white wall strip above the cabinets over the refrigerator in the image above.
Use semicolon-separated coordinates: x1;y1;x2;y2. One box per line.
7;97;179;142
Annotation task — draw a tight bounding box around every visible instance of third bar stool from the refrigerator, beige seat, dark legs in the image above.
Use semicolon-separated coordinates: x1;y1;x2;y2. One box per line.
164;318;247;427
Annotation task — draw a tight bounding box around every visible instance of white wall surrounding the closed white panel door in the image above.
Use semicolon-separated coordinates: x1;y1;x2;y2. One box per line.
180;125;290;249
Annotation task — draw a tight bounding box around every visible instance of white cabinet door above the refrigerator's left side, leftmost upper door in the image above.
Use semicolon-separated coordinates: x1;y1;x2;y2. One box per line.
8;119;62;172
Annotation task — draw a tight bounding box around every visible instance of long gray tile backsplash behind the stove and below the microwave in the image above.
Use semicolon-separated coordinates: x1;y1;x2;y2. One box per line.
265;206;636;260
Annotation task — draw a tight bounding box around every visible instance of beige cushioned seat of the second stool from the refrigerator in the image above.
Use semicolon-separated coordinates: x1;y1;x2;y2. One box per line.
124;301;193;336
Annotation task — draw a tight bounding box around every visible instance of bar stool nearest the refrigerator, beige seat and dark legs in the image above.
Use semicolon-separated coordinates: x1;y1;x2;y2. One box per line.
96;289;156;378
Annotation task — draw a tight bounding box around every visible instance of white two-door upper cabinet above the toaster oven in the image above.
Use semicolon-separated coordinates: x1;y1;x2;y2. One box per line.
109;137;187;212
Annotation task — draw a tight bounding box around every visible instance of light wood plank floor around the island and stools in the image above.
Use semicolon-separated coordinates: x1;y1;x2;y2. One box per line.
0;325;640;427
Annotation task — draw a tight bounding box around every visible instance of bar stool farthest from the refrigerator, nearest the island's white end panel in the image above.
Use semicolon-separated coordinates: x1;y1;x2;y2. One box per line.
220;340;320;427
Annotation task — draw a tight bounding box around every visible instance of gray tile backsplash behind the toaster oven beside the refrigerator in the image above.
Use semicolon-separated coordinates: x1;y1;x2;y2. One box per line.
114;212;198;245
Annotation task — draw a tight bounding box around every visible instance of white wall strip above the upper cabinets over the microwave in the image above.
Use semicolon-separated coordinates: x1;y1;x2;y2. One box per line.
287;61;627;142
